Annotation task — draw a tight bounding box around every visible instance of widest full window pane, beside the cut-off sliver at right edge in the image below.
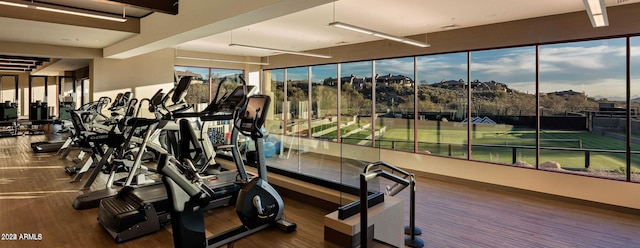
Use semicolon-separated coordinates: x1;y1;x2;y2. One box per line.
538;39;627;180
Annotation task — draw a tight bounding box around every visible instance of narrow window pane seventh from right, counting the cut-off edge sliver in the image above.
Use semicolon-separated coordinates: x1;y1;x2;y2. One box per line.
311;64;338;141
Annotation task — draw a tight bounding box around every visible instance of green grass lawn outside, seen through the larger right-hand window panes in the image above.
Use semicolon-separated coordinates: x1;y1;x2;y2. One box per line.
378;128;640;170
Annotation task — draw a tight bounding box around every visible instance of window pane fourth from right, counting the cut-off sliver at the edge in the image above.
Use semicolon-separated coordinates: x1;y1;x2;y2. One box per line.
417;53;467;158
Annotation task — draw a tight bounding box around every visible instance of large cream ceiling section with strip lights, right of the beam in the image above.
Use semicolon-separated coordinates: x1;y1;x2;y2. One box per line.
175;0;640;57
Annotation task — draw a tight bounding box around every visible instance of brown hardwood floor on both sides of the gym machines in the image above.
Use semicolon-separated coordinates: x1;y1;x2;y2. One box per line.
0;135;640;248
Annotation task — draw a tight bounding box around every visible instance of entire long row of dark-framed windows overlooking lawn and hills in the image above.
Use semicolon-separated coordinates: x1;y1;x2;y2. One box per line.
258;34;640;183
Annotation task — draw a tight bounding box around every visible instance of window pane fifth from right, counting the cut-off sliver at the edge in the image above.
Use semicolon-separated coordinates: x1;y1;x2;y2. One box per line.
375;57;415;152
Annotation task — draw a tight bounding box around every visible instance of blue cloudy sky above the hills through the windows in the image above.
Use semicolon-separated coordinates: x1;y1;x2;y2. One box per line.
274;37;640;100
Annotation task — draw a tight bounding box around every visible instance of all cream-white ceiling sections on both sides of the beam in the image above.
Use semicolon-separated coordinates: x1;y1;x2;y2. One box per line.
0;0;640;73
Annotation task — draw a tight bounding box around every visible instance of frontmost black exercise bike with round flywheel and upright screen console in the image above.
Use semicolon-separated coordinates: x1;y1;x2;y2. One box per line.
158;95;296;247
